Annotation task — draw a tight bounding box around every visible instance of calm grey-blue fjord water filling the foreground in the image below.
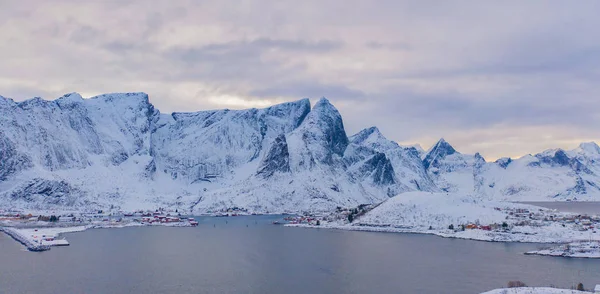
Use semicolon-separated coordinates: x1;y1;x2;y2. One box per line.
0;217;600;294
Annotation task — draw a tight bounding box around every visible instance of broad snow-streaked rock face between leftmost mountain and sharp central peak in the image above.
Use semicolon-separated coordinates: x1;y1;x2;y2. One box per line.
152;99;310;183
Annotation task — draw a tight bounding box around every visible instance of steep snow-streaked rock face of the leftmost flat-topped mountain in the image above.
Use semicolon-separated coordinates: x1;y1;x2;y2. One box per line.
0;93;157;171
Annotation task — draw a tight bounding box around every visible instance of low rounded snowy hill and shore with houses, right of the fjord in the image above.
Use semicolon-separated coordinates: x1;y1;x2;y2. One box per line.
289;192;600;243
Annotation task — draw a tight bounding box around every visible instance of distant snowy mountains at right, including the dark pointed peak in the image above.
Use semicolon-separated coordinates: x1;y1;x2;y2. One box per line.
423;139;600;201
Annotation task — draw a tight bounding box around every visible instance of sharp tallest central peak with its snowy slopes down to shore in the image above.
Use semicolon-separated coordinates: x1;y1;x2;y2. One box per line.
194;99;388;212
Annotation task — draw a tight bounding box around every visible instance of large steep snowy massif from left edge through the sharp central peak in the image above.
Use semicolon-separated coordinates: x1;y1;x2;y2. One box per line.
0;93;393;212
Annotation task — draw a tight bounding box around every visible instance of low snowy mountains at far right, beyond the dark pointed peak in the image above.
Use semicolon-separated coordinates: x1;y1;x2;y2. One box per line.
477;143;600;201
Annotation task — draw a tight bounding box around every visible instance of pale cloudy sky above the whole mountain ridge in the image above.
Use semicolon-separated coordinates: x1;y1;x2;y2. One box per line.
0;0;600;159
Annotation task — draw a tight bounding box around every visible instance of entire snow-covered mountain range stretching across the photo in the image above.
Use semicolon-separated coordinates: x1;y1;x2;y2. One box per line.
0;93;600;213
